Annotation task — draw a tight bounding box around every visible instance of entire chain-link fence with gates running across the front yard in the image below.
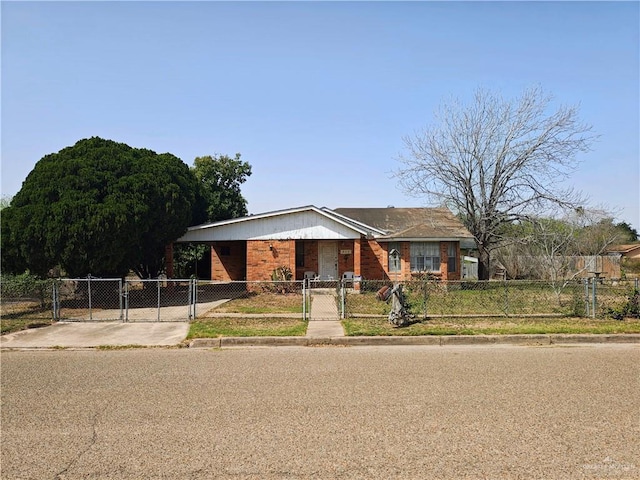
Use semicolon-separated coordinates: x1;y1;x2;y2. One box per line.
1;277;640;322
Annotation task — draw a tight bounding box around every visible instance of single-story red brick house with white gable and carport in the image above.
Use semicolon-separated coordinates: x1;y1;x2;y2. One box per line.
167;206;474;281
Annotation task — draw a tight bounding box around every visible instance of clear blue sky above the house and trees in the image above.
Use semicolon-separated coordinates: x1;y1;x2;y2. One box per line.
1;1;640;229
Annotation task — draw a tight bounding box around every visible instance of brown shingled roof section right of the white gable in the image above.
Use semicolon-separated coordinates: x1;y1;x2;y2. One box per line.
334;208;473;239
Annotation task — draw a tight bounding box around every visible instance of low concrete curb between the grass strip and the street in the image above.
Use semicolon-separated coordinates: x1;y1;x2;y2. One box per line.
189;333;640;348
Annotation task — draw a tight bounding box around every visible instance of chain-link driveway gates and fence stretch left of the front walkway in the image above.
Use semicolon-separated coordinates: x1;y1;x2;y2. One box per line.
49;277;309;322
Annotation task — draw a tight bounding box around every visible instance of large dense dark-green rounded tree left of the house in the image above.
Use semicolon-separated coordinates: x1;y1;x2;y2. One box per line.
1;137;198;278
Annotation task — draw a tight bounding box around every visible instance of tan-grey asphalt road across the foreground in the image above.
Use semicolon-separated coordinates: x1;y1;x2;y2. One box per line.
0;345;640;480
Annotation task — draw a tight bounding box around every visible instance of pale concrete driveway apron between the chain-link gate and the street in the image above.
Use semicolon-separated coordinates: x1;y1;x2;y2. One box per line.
0;322;189;349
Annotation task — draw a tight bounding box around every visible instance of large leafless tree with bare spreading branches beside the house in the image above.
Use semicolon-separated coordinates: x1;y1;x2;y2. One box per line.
396;88;596;279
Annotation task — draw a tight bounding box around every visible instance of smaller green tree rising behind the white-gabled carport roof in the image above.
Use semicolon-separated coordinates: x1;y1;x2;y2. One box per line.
192;153;251;222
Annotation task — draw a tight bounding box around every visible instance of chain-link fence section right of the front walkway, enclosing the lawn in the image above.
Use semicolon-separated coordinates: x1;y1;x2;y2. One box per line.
342;278;638;318
